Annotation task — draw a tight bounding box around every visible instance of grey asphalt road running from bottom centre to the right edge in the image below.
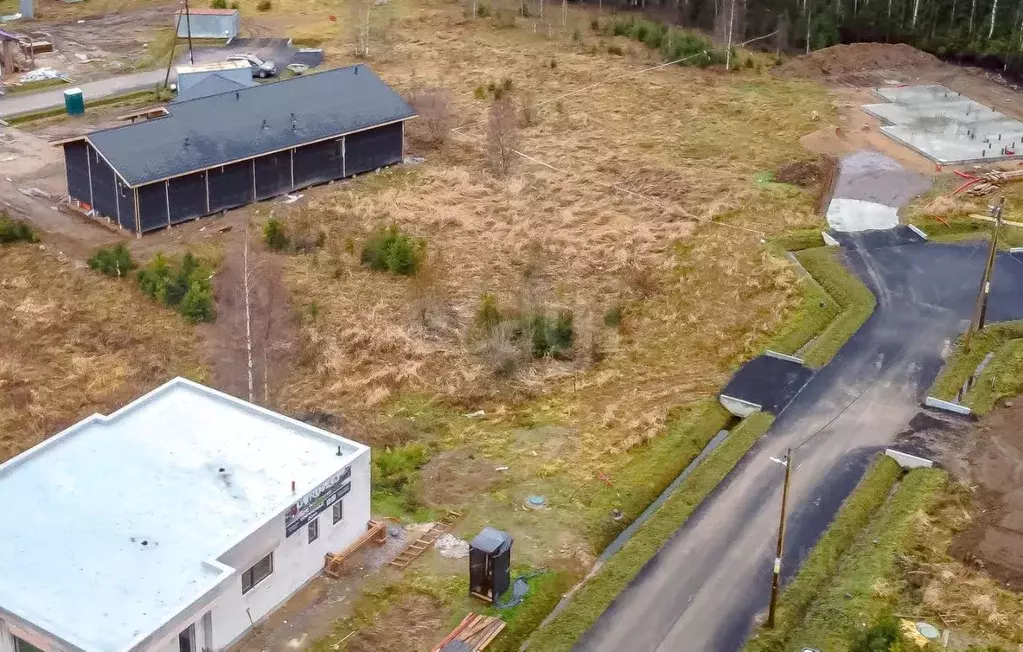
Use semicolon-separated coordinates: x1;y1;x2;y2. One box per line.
576;234;1023;652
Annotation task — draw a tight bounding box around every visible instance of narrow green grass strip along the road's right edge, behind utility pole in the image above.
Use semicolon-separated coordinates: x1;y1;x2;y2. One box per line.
744;457;902;652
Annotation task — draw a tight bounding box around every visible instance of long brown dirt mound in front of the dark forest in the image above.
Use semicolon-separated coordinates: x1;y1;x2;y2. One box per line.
779;43;942;83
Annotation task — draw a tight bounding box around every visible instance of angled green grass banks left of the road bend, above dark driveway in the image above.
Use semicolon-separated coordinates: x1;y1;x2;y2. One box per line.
768;247;877;367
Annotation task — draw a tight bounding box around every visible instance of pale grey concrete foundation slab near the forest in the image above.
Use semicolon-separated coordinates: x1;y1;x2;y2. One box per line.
863;84;1023;164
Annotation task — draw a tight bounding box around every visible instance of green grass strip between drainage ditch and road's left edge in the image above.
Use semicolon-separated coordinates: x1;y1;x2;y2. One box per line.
529;412;773;652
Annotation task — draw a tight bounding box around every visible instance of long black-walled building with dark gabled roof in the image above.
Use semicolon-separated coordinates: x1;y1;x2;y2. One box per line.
61;64;415;233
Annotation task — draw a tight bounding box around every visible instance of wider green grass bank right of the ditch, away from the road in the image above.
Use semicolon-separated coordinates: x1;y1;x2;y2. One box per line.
746;469;946;651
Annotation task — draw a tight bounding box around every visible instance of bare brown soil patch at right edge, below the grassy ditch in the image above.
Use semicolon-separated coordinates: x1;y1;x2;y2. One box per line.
948;404;1023;590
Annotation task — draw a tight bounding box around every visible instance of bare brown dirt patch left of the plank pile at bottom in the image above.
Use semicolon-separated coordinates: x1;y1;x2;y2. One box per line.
347;594;448;652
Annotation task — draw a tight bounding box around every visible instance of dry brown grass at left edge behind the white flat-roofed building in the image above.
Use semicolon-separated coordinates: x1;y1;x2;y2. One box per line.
0;245;205;462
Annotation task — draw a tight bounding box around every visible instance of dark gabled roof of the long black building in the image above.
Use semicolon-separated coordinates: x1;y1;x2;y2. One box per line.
86;64;415;186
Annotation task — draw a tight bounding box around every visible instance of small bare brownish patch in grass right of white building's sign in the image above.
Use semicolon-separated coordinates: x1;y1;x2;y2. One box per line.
421;448;501;507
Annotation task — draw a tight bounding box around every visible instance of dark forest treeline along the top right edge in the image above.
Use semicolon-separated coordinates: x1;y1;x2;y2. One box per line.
585;0;1023;78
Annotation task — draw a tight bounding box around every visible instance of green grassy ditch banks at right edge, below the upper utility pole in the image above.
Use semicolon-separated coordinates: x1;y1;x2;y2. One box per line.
929;321;1023;414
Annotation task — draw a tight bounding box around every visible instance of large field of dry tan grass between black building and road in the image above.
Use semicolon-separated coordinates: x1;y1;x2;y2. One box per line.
270;0;831;474
